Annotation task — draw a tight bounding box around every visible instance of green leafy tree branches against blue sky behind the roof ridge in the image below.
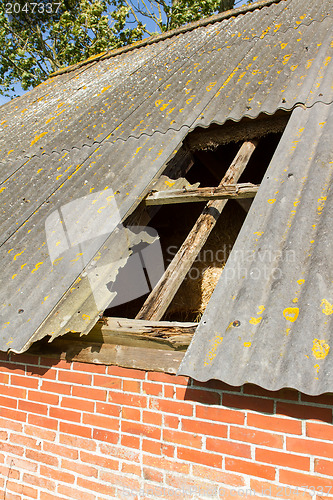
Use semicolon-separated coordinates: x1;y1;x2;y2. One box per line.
0;0;234;96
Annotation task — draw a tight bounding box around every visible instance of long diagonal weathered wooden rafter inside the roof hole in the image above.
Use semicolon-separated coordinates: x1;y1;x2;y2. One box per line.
136;140;258;320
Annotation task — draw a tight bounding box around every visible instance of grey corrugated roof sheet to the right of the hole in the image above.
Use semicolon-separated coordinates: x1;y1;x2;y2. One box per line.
179;103;333;395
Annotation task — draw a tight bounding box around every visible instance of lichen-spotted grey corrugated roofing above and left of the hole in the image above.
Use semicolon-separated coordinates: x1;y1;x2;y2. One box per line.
0;0;333;376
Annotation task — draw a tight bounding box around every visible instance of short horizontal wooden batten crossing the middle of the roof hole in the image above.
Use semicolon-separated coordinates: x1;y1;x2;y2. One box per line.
145;182;259;205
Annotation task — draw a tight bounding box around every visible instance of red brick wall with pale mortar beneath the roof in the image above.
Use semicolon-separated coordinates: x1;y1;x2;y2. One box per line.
0;355;333;500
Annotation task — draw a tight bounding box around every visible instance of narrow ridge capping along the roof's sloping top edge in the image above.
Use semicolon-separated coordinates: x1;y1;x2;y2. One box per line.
48;0;287;79
